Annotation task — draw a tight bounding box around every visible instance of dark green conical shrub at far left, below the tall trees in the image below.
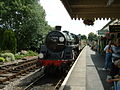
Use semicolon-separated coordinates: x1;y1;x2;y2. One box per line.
2;30;17;53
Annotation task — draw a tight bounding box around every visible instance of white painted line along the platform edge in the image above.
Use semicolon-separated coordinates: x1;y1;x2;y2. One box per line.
59;46;86;90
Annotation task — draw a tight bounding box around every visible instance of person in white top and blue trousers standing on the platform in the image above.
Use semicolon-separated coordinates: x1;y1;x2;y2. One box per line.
103;41;112;70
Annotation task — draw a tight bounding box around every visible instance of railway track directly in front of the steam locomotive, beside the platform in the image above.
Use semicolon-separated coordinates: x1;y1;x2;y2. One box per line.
20;62;72;90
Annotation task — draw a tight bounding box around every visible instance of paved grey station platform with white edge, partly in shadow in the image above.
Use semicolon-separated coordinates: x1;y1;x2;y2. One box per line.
59;46;111;90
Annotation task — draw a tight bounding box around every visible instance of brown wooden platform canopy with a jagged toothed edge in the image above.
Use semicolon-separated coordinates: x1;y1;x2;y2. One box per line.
61;0;120;19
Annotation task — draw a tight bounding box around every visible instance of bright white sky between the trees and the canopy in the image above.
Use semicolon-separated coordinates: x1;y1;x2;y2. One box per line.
40;0;110;36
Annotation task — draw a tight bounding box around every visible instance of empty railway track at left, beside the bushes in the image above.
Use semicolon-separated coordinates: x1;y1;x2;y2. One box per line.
0;59;40;88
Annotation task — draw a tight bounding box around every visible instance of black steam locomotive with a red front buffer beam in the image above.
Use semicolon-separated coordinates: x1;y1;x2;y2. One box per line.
38;26;80;71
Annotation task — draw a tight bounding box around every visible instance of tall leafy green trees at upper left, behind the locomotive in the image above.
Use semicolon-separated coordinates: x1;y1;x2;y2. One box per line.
0;0;51;51
